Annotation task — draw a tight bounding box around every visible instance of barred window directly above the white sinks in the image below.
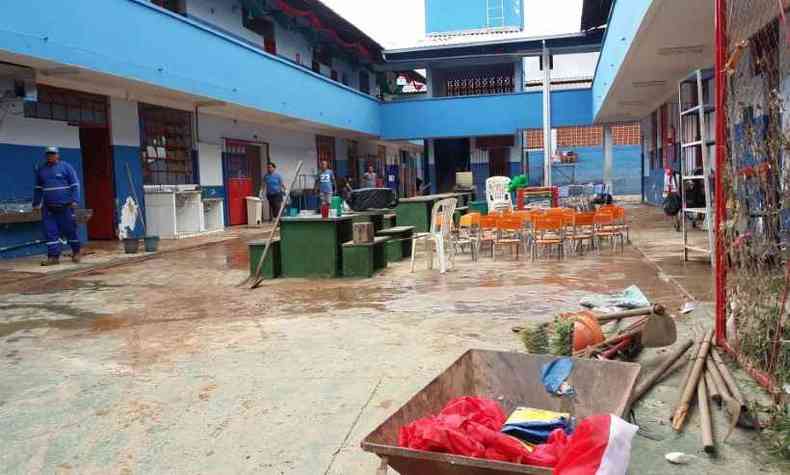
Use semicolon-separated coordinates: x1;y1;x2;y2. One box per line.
139;103;194;185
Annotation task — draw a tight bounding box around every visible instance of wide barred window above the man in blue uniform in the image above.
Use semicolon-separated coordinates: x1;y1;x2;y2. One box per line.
25;84;108;127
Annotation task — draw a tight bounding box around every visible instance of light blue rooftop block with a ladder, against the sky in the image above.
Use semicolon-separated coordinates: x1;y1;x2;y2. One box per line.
425;0;524;34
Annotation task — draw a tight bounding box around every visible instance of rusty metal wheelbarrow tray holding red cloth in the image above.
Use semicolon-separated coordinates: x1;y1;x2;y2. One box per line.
362;350;640;475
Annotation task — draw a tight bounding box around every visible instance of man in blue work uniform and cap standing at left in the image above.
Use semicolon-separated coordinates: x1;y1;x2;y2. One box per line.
33;147;80;266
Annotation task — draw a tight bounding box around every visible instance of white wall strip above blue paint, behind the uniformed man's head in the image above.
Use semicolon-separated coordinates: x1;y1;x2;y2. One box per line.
0;114;80;148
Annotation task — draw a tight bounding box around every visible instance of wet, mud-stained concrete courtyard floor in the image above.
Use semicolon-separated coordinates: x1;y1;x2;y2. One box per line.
0;207;780;475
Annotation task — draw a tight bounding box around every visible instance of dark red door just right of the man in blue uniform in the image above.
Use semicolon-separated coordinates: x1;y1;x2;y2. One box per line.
80;127;115;239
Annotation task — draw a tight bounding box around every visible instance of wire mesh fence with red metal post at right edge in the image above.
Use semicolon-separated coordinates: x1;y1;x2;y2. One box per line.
710;0;790;393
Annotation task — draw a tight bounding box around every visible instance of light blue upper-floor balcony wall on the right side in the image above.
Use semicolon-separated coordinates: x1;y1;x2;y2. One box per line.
592;0;653;121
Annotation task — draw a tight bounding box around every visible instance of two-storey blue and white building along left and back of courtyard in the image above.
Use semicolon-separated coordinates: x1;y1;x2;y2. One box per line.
0;0;640;257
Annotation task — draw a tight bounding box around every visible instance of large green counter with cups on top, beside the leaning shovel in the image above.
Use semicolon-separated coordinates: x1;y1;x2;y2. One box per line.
280;216;353;277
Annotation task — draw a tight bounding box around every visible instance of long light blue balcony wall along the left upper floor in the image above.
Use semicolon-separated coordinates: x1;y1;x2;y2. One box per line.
0;0;380;135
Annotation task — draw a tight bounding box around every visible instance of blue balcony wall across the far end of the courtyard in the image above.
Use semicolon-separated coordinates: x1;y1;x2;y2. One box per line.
381;89;592;140
